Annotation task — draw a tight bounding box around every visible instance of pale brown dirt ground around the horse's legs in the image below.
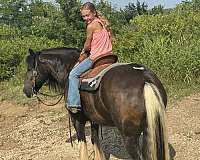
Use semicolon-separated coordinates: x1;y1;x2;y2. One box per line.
0;94;200;160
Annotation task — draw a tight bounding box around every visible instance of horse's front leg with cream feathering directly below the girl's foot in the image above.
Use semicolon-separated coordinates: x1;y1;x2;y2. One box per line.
71;113;89;160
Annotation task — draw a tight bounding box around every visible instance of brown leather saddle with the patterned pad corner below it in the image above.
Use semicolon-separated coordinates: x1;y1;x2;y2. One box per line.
80;54;118;91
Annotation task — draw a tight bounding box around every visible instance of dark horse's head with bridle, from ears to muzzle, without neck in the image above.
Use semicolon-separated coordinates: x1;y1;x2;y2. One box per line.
23;49;48;98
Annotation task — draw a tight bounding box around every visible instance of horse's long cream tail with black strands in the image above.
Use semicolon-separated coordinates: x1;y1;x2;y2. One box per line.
143;83;169;160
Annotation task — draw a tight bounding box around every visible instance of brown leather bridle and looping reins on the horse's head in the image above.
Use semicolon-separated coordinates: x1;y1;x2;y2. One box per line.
31;56;64;106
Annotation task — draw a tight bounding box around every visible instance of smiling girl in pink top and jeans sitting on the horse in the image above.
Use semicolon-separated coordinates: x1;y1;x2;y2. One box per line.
66;2;112;113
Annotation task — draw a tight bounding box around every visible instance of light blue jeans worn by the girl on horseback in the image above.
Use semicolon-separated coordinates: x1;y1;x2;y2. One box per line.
67;57;92;108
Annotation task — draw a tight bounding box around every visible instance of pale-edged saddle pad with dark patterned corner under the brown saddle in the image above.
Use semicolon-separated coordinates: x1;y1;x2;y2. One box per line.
80;63;127;91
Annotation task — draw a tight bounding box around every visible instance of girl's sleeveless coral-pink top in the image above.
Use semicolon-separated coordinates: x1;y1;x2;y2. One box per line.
90;19;112;60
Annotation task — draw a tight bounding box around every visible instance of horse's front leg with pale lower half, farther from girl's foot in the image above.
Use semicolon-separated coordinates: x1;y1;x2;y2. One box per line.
91;123;106;160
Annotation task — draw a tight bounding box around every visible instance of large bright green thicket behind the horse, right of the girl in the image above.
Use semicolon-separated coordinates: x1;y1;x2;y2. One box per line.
115;5;200;83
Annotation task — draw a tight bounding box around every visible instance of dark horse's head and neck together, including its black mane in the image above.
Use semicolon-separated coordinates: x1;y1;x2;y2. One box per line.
23;48;80;98
